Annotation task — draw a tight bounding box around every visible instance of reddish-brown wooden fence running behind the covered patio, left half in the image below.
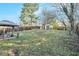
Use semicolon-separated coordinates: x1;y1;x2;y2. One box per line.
0;26;40;35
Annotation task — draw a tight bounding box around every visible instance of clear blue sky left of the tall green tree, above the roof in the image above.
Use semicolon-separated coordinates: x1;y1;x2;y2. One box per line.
0;3;23;24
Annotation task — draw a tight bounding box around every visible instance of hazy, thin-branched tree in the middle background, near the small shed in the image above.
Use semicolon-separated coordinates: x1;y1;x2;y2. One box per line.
42;8;55;29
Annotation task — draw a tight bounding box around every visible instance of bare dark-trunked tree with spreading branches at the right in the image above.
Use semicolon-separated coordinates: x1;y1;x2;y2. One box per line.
60;3;75;31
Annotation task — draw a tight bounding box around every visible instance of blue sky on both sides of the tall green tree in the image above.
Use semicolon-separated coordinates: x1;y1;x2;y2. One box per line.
0;3;65;24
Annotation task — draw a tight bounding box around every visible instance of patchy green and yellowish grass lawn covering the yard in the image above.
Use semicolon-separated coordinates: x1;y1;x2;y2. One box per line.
0;30;78;56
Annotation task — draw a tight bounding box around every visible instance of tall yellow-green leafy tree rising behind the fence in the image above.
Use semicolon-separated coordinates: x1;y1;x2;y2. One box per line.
20;3;38;25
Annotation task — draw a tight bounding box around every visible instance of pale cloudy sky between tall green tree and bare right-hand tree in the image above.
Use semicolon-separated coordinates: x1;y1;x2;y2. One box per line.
36;3;67;21
